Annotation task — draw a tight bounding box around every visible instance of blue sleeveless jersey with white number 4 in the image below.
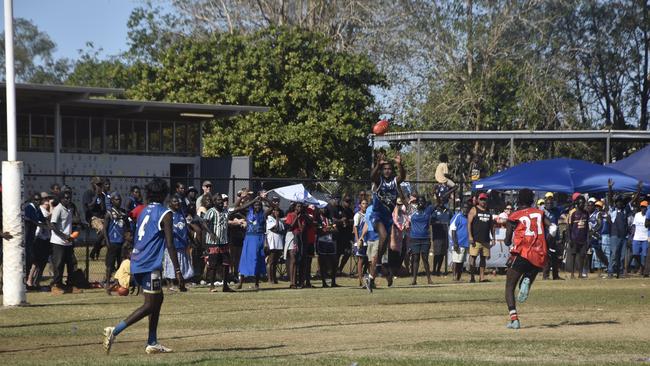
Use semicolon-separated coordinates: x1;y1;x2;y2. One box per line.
131;203;171;273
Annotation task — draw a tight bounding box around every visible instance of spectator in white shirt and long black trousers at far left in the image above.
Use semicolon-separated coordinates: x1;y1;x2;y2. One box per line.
50;192;76;295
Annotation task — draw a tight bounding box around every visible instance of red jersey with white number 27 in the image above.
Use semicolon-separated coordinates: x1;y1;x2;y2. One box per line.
508;208;548;268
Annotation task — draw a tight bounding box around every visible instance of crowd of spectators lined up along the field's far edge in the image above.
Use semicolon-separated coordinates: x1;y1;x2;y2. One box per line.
8;170;650;294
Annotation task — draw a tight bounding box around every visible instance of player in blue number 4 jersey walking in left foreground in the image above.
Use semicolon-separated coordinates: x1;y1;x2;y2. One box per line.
104;178;187;354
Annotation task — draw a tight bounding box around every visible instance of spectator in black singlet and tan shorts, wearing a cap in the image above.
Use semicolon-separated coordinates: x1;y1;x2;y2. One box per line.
467;193;495;282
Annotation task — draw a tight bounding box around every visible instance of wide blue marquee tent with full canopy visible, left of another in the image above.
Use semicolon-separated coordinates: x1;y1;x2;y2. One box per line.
472;158;650;193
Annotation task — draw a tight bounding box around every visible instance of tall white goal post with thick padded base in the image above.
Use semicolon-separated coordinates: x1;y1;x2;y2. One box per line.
2;0;27;306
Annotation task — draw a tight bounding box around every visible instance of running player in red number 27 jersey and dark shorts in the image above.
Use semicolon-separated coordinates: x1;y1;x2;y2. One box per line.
505;188;557;329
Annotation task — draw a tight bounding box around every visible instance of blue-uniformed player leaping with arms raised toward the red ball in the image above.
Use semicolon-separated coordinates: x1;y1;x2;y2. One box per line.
366;153;406;290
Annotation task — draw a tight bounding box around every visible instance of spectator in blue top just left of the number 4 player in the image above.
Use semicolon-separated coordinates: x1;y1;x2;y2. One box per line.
103;192;132;295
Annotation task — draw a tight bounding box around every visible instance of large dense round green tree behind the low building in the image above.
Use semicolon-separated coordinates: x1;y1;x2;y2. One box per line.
129;27;384;178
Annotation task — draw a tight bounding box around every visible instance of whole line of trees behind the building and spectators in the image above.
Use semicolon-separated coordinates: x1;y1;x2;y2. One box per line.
2;0;650;179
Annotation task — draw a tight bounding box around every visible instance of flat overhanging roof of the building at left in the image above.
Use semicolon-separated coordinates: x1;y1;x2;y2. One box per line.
0;83;269;121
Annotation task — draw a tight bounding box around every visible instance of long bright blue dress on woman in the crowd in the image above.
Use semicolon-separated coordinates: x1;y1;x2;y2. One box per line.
239;207;266;276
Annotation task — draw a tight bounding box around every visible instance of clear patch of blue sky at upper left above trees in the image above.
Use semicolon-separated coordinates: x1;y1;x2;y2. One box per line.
0;0;146;59
